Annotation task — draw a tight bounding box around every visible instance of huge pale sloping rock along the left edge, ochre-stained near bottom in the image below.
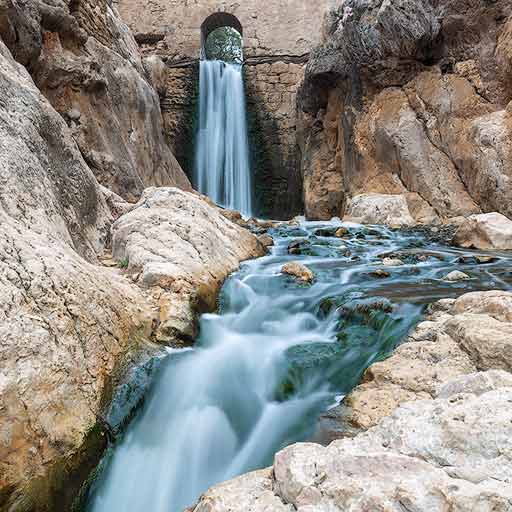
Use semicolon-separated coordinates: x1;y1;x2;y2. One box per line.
0;42;154;511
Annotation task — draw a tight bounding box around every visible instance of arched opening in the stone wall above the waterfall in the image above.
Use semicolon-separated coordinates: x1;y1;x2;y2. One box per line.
201;12;243;64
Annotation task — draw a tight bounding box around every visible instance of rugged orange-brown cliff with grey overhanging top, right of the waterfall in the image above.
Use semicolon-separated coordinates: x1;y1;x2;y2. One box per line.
299;0;512;220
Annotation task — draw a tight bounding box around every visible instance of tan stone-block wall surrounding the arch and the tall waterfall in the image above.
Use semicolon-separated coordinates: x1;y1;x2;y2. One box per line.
117;0;330;218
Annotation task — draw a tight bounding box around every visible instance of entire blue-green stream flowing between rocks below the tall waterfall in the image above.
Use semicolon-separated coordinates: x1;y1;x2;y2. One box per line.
87;221;512;512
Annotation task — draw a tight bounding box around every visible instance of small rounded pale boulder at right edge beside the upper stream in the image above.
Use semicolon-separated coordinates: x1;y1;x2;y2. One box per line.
454;213;512;250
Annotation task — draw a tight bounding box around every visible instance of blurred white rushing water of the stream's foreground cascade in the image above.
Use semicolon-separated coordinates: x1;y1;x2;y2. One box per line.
90;234;335;512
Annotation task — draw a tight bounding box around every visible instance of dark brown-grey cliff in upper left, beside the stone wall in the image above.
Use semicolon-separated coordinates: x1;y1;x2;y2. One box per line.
0;0;190;201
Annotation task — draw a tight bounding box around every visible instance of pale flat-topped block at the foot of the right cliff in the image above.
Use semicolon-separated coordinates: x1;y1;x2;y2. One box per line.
344;194;415;226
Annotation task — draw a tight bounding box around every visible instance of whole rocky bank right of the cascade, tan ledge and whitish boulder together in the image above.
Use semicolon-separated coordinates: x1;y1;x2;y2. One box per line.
192;292;512;512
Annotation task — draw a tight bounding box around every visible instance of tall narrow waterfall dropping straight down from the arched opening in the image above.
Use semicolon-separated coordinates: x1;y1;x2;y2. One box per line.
194;60;252;216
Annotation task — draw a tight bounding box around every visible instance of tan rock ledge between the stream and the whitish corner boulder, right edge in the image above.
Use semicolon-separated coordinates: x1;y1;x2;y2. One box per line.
344;291;512;430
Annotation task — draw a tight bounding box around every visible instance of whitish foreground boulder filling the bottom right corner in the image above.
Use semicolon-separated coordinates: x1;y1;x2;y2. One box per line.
193;376;512;512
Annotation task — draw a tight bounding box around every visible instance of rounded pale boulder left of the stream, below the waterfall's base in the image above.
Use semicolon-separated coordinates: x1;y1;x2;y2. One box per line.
112;188;265;342
